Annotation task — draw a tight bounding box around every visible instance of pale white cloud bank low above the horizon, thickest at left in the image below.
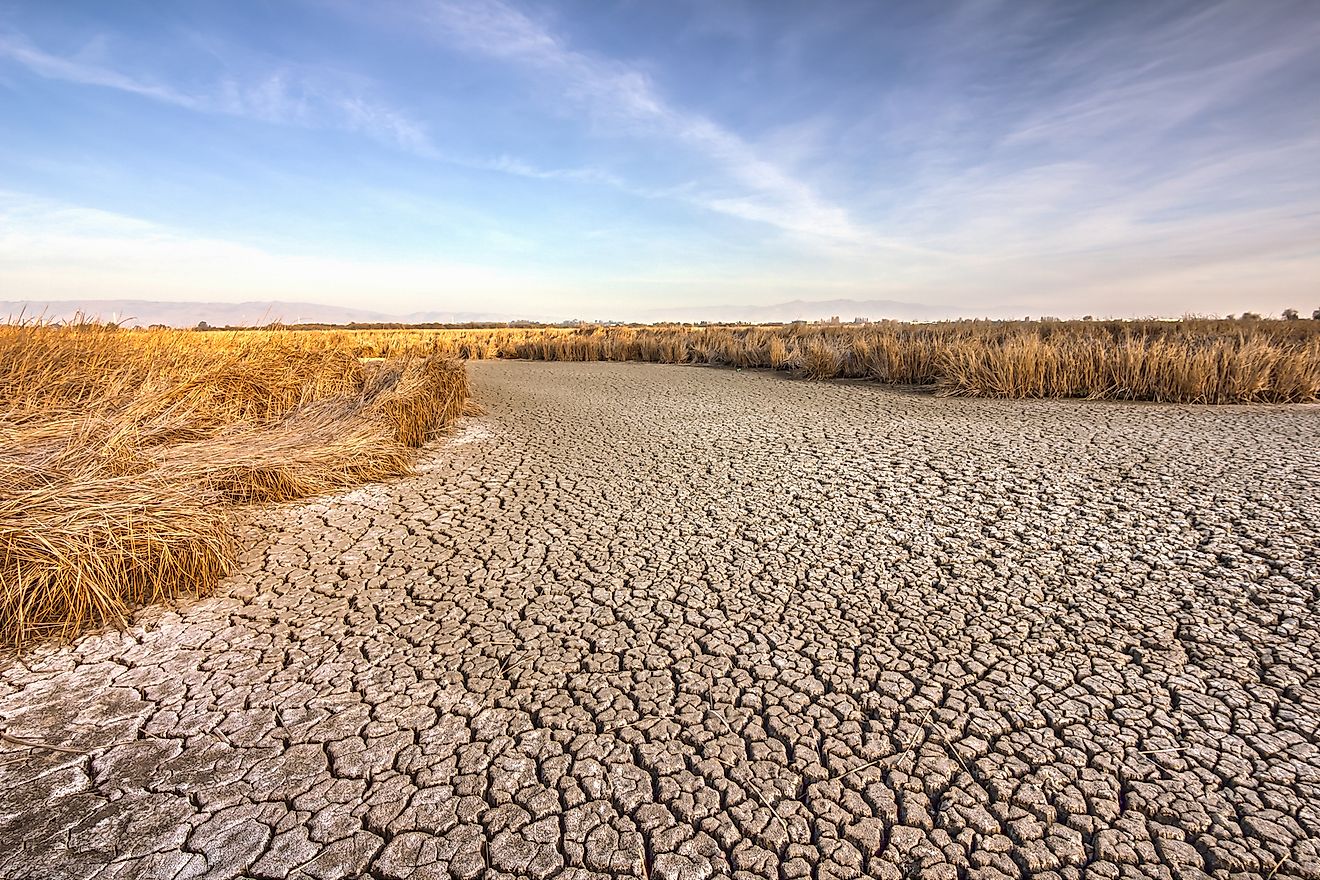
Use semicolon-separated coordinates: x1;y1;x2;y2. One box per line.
0;190;924;319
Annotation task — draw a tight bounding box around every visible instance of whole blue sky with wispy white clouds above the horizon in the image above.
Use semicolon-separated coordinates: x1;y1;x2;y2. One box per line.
0;0;1320;319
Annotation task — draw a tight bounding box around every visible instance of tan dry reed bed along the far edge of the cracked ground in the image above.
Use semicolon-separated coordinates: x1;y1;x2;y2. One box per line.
311;318;1320;404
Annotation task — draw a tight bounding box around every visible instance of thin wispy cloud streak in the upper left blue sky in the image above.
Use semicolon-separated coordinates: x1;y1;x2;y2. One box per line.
0;32;437;157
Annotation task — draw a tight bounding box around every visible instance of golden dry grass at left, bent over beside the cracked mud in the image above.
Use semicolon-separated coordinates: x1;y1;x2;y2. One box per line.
0;325;467;645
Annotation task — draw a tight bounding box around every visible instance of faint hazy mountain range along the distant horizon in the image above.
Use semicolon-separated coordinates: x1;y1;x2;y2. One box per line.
0;299;1022;327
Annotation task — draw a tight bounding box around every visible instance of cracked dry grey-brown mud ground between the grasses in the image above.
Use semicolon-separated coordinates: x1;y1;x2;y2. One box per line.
0;363;1320;880
